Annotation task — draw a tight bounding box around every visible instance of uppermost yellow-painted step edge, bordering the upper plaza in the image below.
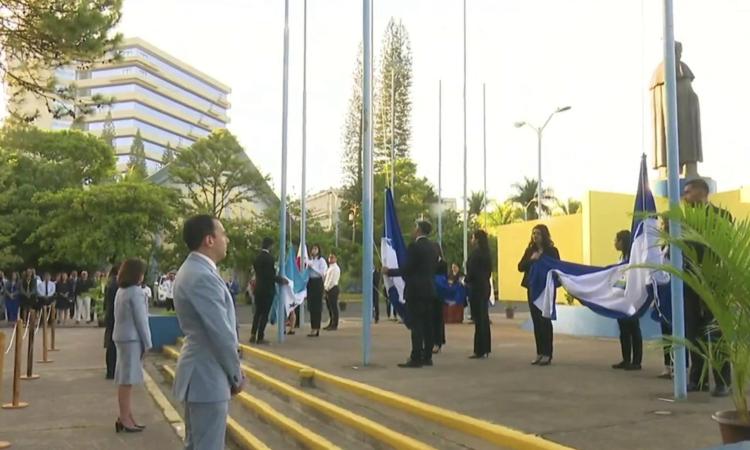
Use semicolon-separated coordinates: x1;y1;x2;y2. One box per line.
240;345;571;450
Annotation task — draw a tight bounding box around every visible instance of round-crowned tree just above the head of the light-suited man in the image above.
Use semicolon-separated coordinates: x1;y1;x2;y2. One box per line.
169;129;268;218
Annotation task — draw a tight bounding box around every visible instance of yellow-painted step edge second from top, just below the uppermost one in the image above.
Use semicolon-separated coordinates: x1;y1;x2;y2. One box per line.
164;347;434;450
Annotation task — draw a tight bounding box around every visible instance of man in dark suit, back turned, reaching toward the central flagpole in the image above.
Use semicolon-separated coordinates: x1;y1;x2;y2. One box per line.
383;221;438;367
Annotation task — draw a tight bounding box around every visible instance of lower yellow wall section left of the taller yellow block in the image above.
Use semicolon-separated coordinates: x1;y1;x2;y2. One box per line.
502;214;583;301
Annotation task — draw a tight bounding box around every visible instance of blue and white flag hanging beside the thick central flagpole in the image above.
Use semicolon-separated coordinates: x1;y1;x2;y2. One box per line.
380;189;407;323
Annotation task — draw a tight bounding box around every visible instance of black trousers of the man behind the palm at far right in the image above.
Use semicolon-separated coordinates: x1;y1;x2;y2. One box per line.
685;289;732;386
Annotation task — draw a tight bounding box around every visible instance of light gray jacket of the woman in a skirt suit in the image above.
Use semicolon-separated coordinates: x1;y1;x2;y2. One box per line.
112;286;151;352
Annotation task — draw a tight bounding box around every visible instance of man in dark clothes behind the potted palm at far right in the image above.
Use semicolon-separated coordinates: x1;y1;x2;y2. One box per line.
683;178;734;397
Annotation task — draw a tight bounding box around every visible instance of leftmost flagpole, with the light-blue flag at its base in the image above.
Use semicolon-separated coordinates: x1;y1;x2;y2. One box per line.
276;0;289;343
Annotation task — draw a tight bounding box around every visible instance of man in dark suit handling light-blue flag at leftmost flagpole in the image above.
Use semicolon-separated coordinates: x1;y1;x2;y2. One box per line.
250;238;286;344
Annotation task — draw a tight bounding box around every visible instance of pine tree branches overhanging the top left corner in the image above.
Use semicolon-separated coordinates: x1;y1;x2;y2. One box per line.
0;0;122;120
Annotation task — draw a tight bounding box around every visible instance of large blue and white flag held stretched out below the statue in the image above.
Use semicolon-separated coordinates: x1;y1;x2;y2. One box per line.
529;156;662;319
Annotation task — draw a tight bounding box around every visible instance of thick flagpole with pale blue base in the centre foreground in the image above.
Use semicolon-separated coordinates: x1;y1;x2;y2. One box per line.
362;0;374;366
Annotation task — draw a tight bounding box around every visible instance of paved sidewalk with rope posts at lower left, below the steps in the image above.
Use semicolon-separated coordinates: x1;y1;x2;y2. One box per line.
0;327;182;450
